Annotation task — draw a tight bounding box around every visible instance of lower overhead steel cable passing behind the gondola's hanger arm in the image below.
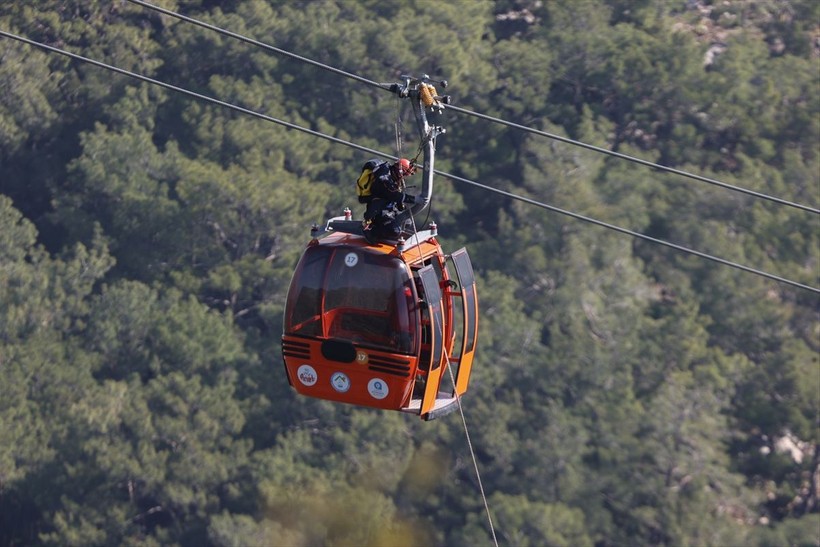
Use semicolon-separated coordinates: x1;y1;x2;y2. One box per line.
0;30;820;294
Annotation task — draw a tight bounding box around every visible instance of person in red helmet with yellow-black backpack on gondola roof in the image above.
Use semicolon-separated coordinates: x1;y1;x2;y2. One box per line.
357;158;416;240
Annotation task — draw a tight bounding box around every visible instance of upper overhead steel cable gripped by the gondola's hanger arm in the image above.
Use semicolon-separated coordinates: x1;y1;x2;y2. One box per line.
128;0;820;214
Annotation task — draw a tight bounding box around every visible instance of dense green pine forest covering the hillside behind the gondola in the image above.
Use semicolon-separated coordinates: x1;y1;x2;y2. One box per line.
0;0;820;547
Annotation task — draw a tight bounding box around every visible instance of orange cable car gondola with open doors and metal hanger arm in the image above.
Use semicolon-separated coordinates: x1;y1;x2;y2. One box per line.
282;77;478;420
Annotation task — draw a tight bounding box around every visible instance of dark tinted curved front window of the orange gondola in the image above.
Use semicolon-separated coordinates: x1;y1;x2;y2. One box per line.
285;245;418;353
